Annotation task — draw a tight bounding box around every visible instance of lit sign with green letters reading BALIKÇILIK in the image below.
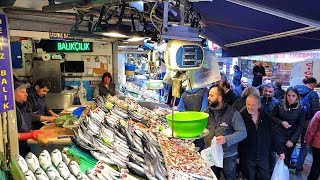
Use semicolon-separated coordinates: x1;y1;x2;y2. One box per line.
55;41;93;52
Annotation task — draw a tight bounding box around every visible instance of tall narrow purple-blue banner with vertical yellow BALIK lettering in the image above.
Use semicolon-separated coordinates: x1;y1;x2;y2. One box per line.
0;13;14;113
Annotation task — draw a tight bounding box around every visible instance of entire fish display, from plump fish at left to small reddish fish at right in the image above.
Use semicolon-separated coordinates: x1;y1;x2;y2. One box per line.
18;96;215;180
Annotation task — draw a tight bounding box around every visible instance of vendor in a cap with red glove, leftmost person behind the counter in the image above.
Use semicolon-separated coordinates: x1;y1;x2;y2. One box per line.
14;82;42;157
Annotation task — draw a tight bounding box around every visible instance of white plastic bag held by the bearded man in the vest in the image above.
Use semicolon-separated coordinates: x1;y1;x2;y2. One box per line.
201;137;223;168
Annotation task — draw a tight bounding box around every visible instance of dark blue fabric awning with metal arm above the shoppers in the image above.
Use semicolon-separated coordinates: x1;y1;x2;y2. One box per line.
193;0;320;57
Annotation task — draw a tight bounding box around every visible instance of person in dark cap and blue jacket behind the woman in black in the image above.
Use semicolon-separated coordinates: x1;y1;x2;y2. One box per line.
295;77;320;173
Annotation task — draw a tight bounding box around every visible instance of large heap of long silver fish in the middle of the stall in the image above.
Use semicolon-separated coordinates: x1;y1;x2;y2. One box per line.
72;106;167;180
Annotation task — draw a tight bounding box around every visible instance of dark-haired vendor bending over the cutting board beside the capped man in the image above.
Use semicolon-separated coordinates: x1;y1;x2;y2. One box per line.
27;79;59;130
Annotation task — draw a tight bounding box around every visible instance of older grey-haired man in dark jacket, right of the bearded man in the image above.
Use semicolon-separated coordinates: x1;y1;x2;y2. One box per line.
239;95;285;180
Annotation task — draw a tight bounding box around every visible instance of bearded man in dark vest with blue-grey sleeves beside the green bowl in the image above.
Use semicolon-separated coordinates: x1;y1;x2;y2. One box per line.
204;86;247;180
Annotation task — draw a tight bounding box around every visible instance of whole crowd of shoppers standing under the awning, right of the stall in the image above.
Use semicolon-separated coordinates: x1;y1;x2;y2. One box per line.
178;65;320;180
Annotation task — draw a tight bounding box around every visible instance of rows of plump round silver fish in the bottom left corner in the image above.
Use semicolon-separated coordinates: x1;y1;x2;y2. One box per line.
17;149;90;180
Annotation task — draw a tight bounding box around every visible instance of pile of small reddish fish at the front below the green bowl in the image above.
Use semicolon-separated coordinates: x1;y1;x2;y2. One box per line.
159;138;215;180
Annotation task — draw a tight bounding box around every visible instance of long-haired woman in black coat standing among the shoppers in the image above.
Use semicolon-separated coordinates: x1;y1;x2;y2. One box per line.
271;87;305;166
